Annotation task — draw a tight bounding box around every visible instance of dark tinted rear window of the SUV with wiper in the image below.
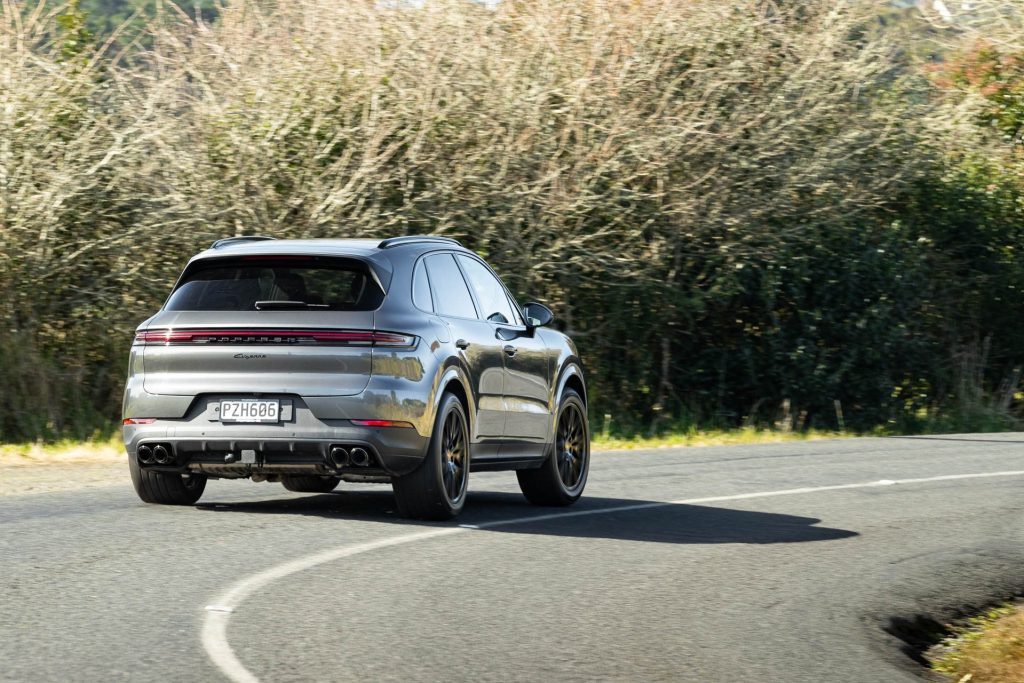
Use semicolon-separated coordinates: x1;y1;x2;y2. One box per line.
164;257;384;310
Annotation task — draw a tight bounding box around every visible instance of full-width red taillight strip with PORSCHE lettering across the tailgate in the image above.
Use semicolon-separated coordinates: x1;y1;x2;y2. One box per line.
135;330;416;346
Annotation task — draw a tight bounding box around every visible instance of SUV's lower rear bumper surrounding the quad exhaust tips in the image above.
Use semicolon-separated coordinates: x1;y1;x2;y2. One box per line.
123;396;430;476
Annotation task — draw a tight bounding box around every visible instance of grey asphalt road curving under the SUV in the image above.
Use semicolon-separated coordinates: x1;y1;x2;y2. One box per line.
0;434;1024;683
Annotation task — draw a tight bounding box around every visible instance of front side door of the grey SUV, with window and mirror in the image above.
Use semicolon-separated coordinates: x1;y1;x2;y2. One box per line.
456;254;551;459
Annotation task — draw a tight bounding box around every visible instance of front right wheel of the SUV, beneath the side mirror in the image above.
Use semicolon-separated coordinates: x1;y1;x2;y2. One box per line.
516;389;590;507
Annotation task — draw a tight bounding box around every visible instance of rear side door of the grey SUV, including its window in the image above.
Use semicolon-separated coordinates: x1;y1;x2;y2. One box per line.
423;252;505;444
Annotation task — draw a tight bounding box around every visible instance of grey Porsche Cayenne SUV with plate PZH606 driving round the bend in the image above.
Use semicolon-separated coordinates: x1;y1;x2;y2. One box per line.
123;237;590;519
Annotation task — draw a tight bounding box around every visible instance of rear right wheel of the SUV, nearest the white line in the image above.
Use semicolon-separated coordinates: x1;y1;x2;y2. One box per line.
392;393;469;519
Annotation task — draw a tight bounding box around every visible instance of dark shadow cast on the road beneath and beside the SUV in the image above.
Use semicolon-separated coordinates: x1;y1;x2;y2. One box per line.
196;492;858;544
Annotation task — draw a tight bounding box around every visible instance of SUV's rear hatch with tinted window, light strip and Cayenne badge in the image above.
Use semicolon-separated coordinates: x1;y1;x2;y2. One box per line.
135;255;411;396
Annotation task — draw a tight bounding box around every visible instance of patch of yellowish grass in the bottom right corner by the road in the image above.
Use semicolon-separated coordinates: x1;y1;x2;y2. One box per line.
931;603;1024;683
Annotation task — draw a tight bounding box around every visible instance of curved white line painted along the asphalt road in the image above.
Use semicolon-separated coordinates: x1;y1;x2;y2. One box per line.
201;470;1024;683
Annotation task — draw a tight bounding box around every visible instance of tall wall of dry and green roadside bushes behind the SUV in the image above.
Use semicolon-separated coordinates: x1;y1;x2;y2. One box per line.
0;0;1024;440
